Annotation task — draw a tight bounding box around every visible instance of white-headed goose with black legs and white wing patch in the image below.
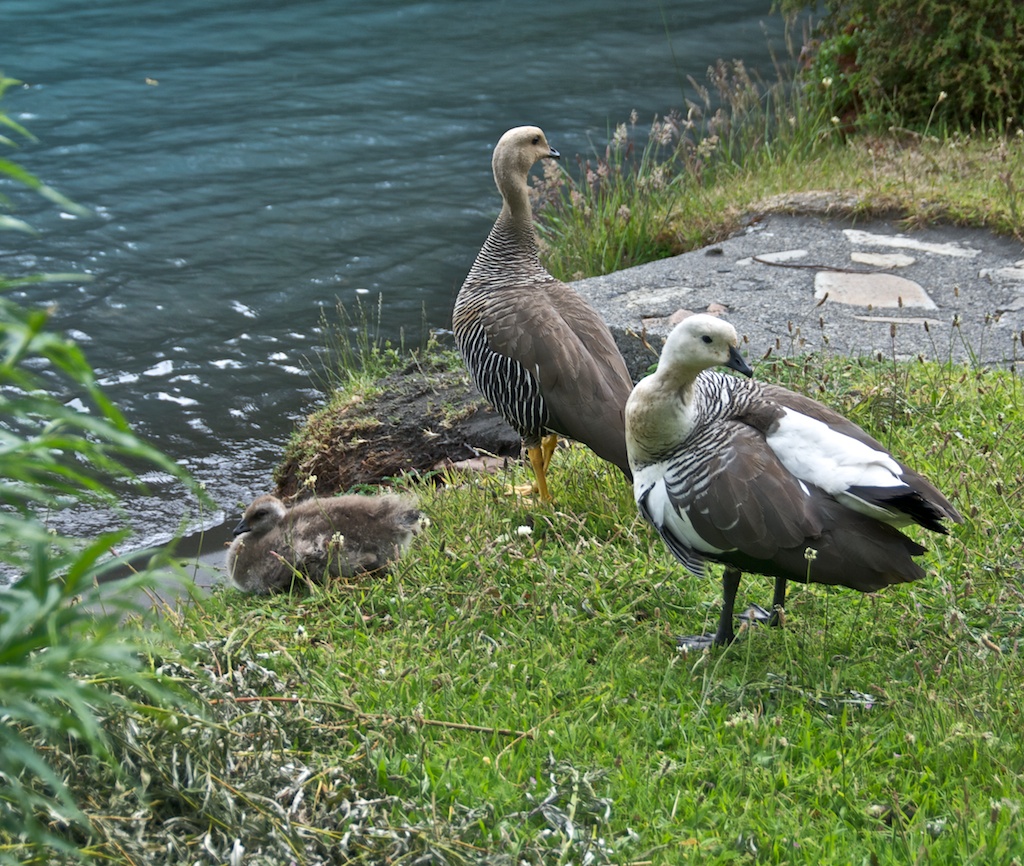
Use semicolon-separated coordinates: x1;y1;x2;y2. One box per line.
626;314;963;647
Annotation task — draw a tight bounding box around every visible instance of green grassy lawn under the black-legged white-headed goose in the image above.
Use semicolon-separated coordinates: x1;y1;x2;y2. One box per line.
28;335;1024;866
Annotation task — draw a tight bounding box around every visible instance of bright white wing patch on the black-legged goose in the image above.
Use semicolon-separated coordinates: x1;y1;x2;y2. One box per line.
767;408;905;496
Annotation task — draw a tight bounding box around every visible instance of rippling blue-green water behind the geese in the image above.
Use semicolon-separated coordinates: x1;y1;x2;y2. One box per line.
0;0;783;545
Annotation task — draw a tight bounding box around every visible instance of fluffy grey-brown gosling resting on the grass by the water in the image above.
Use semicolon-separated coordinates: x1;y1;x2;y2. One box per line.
227;494;429;593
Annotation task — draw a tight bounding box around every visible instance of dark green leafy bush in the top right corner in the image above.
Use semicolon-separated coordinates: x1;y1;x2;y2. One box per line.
782;0;1024;130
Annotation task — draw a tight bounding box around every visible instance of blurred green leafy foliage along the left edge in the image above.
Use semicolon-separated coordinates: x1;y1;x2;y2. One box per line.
0;72;202;864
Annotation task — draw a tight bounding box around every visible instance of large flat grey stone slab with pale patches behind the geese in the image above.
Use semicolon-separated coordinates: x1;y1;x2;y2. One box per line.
574;214;1024;378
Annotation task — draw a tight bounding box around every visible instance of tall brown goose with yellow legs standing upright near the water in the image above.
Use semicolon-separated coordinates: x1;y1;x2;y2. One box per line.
453;126;633;501
